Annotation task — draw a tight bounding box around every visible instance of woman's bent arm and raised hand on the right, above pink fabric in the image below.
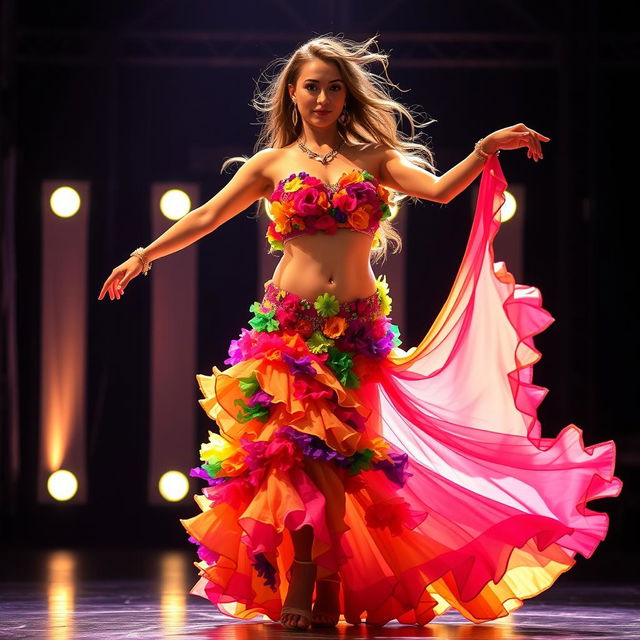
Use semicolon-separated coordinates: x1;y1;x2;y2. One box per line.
380;123;550;204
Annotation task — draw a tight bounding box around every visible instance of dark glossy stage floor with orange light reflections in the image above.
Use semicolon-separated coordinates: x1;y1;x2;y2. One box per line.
0;550;640;640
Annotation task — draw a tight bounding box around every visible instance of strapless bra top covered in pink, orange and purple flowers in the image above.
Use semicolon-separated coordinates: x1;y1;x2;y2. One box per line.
266;169;391;253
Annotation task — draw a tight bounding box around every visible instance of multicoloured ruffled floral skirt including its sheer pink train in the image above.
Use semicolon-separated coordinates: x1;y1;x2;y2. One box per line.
180;156;622;625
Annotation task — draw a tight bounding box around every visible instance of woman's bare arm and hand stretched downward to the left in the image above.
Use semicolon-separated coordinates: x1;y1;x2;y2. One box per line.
98;150;272;300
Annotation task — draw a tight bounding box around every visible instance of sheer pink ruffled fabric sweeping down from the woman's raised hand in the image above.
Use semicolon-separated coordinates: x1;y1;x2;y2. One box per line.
368;156;622;598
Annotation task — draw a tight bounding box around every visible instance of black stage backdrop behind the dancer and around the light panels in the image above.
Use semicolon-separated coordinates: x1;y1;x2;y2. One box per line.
0;0;640;579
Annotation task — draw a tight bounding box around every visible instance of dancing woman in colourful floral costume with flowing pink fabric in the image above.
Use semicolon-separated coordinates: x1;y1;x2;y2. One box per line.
99;37;621;629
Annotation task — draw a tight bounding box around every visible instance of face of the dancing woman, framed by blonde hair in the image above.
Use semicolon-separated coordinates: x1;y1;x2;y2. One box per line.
289;58;347;127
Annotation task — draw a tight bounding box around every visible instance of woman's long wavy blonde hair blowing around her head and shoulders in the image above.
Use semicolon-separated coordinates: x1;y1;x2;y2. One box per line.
228;35;436;262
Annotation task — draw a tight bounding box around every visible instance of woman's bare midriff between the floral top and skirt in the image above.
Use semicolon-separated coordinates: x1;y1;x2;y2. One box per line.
272;229;376;302
